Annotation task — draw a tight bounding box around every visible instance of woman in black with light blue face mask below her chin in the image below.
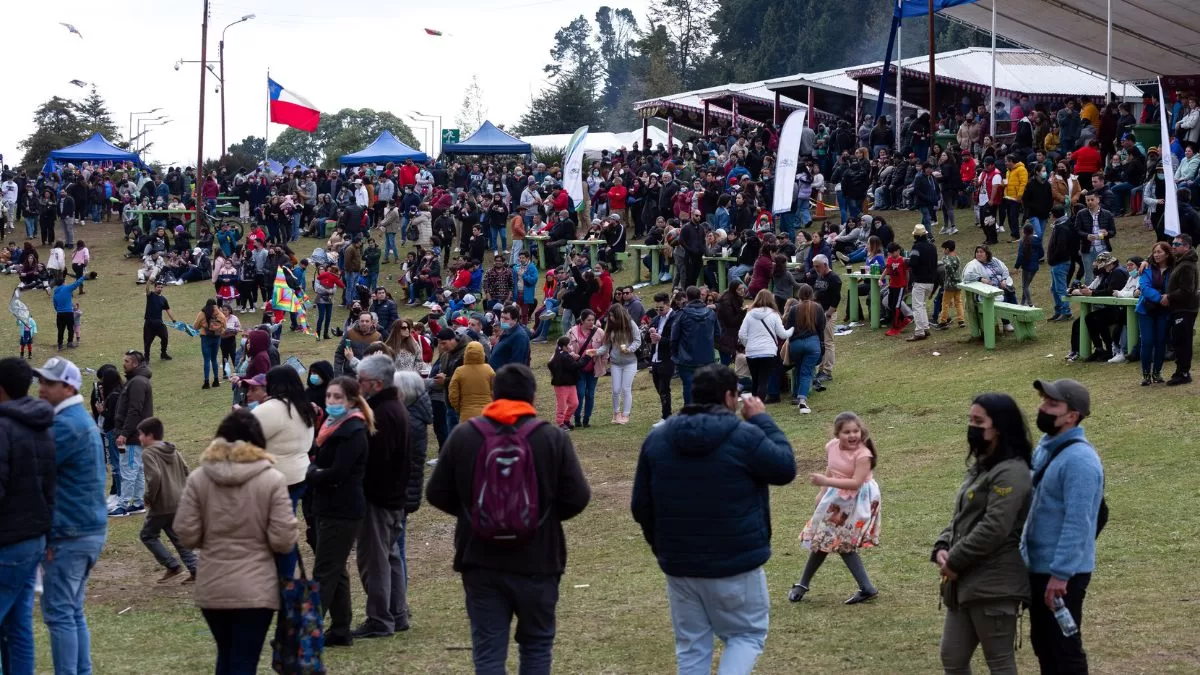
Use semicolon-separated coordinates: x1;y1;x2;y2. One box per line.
307;377;374;646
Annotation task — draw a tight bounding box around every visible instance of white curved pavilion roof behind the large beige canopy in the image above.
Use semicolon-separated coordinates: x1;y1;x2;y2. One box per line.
845;46;1141;100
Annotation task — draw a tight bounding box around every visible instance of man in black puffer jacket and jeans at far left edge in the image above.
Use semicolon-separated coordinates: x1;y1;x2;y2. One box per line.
0;358;55;673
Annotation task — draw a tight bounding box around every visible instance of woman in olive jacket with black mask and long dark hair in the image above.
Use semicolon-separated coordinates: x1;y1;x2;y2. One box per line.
930;394;1033;673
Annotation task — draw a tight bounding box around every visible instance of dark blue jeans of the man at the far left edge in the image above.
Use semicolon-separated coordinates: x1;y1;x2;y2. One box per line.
0;536;46;675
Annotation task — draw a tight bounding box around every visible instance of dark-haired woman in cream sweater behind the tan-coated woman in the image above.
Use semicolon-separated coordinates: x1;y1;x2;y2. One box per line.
252;365;316;579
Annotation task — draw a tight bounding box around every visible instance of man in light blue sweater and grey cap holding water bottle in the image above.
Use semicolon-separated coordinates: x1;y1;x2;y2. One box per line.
1021;380;1104;674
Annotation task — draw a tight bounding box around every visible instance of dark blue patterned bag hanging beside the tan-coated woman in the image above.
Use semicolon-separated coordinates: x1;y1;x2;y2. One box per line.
271;556;325;675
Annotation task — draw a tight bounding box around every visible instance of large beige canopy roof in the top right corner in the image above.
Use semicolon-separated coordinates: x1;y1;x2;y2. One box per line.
941;0;1200;82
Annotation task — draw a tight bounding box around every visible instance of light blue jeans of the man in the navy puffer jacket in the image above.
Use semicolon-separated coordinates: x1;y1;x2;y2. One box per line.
667;567;770;675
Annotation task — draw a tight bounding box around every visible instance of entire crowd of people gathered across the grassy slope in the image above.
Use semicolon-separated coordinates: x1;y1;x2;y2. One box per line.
0;84;1200;673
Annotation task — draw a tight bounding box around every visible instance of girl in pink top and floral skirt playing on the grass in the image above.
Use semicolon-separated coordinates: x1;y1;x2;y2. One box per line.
787;412;880;604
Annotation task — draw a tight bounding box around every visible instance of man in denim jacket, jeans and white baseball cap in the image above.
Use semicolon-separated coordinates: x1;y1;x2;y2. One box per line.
36;357;108;674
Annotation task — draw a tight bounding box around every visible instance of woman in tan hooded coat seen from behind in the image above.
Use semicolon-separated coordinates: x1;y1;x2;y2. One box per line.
174;410;298;674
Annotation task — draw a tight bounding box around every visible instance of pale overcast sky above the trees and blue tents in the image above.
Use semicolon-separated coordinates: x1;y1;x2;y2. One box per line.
7;0;649;165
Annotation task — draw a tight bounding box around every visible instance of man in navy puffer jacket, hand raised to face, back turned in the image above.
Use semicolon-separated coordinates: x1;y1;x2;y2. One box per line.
632;364;796;673
